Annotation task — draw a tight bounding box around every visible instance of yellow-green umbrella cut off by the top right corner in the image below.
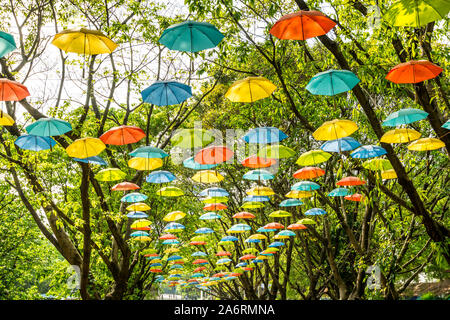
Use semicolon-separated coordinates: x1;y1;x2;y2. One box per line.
383;0;450;28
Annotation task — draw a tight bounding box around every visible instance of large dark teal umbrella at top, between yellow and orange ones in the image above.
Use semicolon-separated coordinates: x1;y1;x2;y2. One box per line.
159;20;224;52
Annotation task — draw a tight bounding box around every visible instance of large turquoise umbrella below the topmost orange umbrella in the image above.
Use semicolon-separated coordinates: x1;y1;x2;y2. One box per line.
305;70;360;95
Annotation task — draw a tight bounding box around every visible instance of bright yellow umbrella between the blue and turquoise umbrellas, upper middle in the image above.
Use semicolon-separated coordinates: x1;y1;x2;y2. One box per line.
225;77;277;102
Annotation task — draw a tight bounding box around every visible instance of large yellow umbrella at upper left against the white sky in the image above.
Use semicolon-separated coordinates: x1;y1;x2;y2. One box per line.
52;28;117;55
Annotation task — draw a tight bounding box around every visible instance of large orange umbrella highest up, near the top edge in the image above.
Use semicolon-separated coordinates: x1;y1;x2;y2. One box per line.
270;11;336;40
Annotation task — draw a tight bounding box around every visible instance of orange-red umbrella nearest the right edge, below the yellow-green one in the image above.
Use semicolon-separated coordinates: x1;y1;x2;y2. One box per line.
386;60;442;83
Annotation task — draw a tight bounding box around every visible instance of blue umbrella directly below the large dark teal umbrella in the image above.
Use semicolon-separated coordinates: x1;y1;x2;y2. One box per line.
141;81;192;106
